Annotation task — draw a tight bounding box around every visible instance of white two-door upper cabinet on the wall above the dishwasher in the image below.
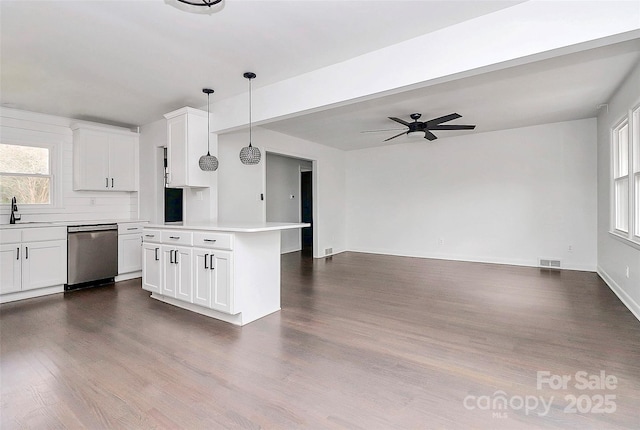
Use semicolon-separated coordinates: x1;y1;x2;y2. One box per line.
72;124;138;191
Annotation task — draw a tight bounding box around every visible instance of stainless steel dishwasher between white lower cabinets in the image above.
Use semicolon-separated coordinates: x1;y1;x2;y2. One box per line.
64;224;118;290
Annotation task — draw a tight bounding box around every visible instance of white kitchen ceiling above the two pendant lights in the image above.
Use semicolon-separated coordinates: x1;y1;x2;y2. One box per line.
0;0;520;127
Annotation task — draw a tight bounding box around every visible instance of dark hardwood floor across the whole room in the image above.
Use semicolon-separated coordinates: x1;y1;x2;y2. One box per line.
0;253;640;430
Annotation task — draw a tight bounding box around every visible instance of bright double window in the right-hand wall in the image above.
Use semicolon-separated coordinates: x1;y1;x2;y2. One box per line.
611;106;640;244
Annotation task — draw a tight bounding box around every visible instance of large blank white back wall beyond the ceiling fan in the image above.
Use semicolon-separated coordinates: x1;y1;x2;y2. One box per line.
346;119;596;270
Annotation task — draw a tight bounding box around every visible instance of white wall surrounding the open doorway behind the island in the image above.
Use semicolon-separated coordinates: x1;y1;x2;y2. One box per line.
218;127;346;257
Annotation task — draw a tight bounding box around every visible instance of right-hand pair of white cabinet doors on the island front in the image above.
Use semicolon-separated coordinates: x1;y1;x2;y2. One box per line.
193;248;235;314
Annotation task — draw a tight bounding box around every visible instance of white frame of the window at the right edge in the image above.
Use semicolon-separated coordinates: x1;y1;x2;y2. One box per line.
610;105;640;249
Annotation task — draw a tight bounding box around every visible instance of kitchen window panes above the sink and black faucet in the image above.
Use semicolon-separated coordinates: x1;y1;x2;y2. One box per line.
0;143;53;205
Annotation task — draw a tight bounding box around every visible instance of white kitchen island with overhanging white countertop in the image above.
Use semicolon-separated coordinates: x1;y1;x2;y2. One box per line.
142;223;309;325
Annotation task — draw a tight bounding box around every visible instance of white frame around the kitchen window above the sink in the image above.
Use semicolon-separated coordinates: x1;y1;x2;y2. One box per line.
0;136;62;215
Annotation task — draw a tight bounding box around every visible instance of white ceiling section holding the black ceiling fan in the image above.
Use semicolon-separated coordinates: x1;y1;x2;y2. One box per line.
263;39;640;150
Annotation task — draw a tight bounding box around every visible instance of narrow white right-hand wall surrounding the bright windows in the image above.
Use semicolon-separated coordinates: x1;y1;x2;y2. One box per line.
598;65;640;319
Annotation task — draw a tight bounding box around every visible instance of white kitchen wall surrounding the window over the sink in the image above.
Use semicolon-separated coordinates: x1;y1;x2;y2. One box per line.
0;108;138;224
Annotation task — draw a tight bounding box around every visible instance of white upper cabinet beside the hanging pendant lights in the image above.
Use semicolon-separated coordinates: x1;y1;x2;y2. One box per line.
164;107;212;188
